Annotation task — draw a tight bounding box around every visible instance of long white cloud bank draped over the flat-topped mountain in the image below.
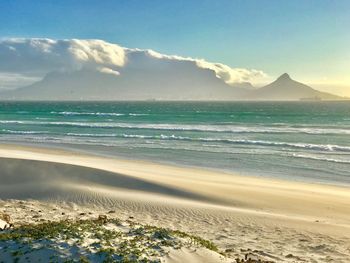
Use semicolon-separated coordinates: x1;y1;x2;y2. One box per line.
0;38;266;88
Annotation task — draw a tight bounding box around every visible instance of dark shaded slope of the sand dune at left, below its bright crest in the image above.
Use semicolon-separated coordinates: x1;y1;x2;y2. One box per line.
0;158;205;203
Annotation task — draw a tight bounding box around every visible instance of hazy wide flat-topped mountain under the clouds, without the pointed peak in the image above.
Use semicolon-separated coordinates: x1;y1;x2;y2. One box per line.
0;65;247;101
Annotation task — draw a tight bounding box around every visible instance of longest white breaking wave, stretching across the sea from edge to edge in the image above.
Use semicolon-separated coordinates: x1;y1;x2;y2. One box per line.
0;120;350;135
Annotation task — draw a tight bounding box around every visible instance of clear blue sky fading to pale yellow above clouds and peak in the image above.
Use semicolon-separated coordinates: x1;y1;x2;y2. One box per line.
0;0;350;96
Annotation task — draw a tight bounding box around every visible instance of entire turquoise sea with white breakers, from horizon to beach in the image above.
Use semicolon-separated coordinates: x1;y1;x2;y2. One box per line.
0;102;350;184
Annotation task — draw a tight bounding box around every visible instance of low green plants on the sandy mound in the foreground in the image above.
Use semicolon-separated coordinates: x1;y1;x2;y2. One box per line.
0;216;223;263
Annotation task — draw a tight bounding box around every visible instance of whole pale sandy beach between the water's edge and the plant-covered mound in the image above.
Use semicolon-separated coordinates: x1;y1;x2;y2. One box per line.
0;145;350;262
